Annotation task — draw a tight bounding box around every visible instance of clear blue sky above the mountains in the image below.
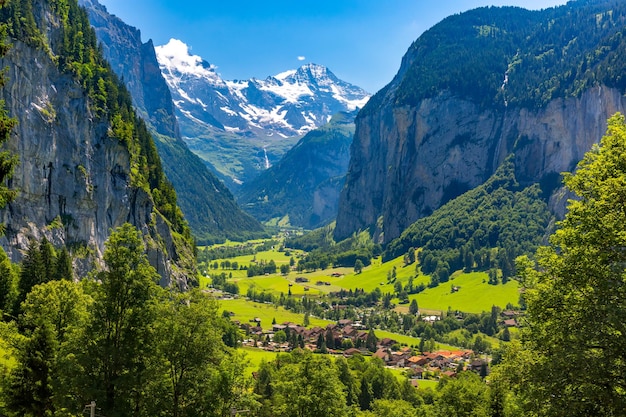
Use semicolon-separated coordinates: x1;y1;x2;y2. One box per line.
99;0;566;93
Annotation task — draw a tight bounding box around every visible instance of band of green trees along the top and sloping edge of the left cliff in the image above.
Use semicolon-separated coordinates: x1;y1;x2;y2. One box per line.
0;0;191;244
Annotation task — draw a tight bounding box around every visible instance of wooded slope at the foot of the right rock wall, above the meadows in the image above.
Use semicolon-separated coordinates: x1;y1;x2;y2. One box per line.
383;157;550;286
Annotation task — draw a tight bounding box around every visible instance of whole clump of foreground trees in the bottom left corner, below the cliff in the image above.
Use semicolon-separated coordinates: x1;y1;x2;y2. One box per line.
0;224;251;416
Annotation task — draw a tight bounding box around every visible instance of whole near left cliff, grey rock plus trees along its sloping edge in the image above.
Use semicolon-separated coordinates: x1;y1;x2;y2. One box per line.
0;0;195;285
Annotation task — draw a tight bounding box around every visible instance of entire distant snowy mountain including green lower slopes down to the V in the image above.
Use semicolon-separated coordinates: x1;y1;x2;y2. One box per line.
156;39;369;188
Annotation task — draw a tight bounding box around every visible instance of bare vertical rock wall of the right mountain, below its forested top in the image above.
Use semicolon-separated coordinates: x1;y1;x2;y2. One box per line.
336;87;626;241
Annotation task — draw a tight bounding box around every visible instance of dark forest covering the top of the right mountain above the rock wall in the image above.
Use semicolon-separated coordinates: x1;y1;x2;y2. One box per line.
359;0;626;117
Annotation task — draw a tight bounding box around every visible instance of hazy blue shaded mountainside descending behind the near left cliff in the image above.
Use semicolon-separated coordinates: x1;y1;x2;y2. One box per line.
79;0;264;243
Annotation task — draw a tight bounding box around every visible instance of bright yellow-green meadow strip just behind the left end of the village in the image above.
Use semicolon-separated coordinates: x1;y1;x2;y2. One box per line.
219;298;333;330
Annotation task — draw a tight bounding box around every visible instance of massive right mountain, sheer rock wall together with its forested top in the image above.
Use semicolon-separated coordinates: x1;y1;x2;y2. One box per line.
335;1;626;242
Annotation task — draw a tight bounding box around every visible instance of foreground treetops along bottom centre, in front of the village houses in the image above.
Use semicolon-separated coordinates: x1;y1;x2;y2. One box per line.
254;350;502;417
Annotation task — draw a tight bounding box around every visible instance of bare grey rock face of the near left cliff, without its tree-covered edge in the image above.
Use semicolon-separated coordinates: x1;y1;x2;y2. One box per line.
0;1;195;286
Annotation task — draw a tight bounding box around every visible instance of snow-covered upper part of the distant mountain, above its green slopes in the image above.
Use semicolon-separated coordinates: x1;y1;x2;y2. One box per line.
155;39;370;138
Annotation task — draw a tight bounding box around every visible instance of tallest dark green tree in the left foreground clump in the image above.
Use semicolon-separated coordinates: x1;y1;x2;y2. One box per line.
73;223;159;415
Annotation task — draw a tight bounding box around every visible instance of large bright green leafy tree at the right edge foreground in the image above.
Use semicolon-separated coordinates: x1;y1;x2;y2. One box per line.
508;114;626;416
